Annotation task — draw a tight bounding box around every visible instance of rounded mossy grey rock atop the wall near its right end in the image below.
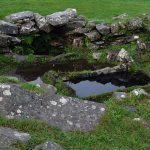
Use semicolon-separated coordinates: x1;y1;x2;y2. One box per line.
127;18;143;30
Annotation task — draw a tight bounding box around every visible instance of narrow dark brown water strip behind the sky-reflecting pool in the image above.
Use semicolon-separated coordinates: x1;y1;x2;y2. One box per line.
15;60;113;81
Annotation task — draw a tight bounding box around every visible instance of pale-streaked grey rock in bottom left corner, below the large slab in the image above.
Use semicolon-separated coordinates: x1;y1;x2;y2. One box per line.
0;127;31;145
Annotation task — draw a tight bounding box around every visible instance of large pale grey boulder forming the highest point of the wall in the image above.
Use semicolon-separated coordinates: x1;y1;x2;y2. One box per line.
46;9;77;26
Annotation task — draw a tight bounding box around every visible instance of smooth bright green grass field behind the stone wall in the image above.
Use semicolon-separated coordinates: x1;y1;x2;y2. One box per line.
0;0;150;20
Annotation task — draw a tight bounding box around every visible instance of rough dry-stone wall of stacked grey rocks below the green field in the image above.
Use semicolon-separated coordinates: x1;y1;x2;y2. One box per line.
0;9;149;53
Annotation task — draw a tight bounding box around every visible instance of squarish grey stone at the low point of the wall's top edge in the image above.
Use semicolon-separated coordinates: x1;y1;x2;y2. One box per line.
96;24;110;35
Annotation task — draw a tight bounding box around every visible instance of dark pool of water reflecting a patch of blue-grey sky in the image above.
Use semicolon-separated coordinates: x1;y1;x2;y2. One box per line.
66;73;150;97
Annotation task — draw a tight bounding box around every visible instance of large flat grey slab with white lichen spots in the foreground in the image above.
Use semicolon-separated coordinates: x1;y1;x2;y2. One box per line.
0;84;106;131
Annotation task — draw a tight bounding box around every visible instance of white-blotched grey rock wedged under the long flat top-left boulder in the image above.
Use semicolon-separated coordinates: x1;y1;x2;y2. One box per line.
19;21;38;34
